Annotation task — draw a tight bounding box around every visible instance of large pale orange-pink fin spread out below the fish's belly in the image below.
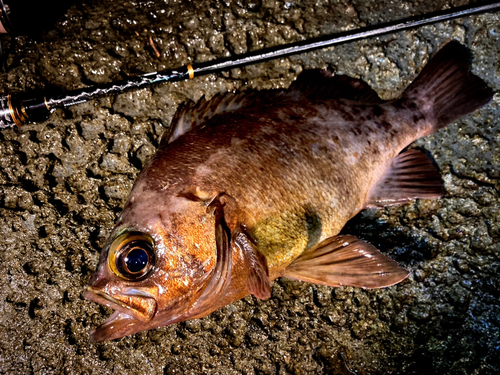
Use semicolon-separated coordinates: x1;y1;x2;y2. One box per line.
283;235;409;289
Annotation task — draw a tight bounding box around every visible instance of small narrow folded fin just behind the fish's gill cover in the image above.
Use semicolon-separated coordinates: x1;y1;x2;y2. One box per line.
234;231;271;299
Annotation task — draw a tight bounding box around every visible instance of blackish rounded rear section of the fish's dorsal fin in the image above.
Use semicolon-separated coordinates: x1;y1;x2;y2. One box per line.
289;69;382;104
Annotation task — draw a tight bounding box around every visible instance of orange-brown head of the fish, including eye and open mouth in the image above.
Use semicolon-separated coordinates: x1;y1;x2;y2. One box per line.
84;181;216;341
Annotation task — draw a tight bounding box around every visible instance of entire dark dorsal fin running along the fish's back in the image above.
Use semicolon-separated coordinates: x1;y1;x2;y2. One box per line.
160;69;381;149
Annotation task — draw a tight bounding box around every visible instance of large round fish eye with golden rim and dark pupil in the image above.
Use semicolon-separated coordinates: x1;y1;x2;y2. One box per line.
108;232;156;281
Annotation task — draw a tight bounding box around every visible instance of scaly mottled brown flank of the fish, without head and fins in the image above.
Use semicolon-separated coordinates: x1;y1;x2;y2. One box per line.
147;98;422;278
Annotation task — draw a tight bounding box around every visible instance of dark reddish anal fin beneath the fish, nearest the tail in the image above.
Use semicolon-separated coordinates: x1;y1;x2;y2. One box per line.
366;149;445;208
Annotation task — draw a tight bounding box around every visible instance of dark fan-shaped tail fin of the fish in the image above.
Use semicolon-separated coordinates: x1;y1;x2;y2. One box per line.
403;41;493;132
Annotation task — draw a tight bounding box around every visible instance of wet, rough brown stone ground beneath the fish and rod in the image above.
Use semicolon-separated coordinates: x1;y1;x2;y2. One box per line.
0;0;500;375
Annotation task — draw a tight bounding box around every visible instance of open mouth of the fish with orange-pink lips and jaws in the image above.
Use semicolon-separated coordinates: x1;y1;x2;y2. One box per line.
83;286;156;342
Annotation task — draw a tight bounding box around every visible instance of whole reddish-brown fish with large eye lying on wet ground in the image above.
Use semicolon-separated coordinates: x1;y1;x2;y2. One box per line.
83;41;493;342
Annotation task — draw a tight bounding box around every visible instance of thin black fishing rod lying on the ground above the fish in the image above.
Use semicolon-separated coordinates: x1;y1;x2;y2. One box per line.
0;1;500;129
